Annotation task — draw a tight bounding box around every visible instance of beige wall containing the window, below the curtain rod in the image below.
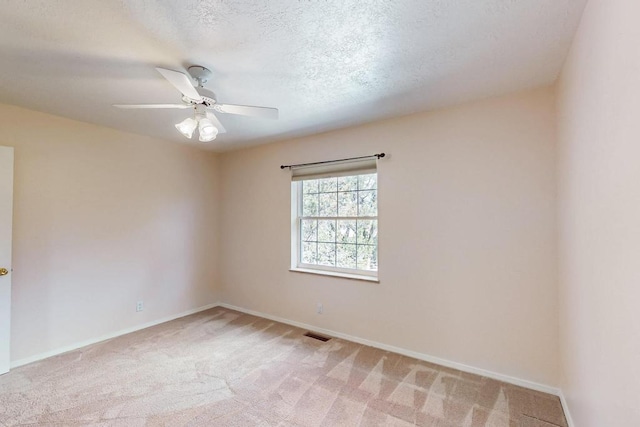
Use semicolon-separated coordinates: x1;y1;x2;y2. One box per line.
221;89;558;385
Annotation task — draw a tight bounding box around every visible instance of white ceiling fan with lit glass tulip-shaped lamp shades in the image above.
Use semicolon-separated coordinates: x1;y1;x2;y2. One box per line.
113;65;278;142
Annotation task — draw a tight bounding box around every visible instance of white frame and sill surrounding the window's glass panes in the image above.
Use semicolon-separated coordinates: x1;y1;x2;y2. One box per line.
291;170;380;282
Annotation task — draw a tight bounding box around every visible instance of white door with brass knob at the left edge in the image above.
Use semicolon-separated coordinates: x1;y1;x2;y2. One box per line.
0;146;13;374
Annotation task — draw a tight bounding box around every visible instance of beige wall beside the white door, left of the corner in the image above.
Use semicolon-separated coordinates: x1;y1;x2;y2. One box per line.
0;105;219;361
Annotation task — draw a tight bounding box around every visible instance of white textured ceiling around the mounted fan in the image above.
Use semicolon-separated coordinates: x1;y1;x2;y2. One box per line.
0;0;586;150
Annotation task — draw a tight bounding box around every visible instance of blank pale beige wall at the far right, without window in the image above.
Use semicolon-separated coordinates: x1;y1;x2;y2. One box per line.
558;0;640;427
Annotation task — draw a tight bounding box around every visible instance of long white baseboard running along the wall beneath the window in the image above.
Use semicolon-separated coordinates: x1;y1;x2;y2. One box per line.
218;303;560;398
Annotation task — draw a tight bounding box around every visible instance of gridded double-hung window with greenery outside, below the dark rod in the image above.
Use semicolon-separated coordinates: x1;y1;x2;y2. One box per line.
292;163;378;279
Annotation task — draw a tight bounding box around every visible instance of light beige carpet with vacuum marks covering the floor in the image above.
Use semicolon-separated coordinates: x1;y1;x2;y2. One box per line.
0;307;566;427
